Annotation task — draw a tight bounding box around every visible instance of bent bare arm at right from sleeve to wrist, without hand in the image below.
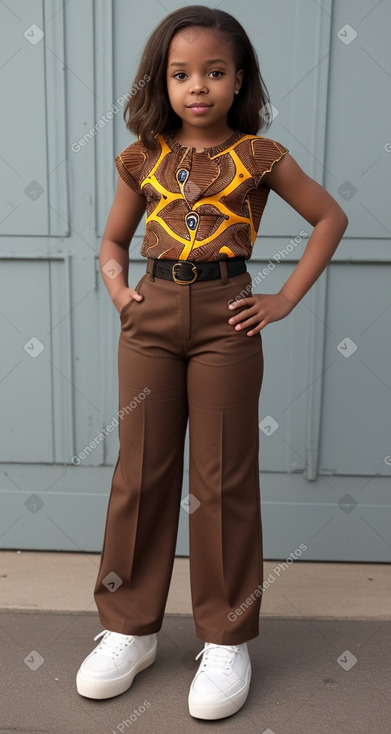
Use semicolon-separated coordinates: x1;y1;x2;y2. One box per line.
264;153;349;308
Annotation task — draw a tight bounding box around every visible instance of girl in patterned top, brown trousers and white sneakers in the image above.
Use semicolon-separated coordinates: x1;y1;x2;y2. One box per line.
77;5;348;719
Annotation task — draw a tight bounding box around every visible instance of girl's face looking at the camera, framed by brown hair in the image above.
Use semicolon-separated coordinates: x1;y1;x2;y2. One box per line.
167;27;243;132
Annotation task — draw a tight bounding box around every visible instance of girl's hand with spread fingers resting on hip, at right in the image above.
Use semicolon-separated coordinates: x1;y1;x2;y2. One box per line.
228;293;296;336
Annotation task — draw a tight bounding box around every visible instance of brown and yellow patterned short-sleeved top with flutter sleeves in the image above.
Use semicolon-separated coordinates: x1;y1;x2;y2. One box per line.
115;130;289;261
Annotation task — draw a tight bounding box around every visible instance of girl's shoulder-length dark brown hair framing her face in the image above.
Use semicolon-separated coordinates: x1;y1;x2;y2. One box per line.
123;5;270;151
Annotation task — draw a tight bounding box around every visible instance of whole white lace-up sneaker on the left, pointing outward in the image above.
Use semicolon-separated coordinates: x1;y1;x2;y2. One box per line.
76;630;157;698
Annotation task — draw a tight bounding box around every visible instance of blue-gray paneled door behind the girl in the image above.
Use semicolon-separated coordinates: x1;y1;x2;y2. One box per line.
0;0;391;561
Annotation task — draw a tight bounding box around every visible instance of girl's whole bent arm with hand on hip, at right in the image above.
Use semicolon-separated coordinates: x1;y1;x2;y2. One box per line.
228;153;348;336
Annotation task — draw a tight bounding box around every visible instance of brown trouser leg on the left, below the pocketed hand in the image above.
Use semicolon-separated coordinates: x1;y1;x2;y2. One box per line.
94;274;188;635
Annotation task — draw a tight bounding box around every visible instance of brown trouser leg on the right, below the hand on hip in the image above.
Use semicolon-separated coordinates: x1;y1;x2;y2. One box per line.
187;273;263;644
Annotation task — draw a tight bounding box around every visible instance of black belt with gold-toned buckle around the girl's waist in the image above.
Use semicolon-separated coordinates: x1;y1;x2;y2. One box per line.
152;257;247;285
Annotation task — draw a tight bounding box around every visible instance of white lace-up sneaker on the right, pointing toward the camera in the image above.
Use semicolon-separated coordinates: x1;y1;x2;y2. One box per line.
189;642;251;719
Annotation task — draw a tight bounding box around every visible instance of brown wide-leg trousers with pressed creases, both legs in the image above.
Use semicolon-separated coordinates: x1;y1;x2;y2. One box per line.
94;258;263;645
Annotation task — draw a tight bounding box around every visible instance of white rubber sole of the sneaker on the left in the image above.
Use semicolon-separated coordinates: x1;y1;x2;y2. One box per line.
76;641;157;699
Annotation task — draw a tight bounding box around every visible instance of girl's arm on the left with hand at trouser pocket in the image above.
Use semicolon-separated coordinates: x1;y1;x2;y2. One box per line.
99;176;146;312
